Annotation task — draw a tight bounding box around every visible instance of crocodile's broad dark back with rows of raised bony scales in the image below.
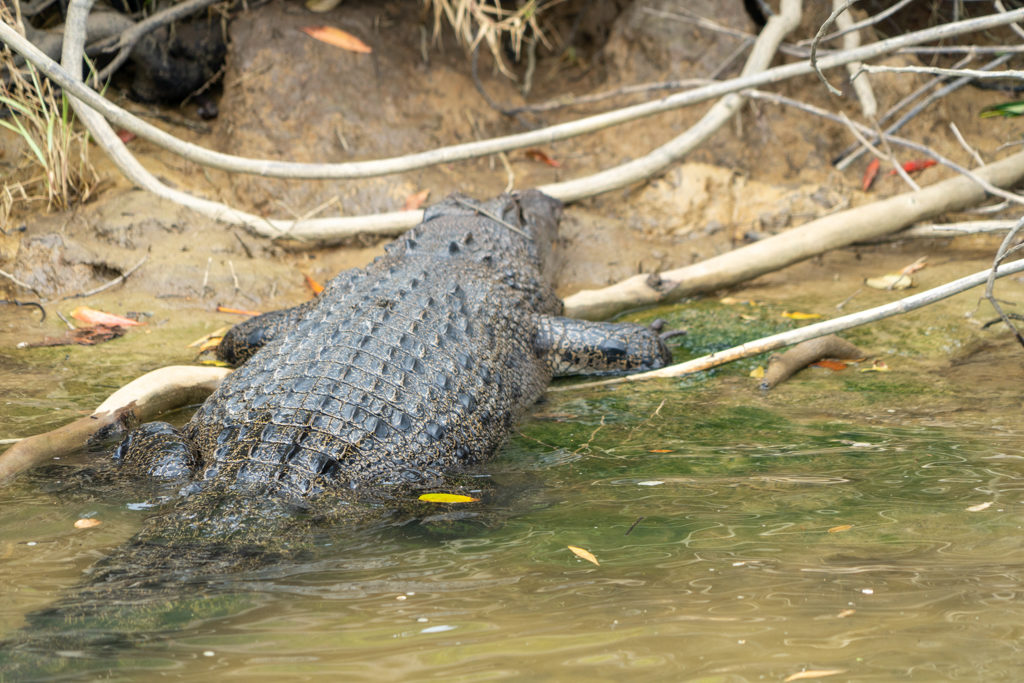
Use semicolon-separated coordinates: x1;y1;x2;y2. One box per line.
183;189;561;498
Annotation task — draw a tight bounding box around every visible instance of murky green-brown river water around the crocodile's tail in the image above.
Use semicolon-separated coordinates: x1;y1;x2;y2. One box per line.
0;301;1024;681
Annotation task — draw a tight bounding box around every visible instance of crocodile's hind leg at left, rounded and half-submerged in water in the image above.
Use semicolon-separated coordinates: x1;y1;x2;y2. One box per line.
114;422;199;479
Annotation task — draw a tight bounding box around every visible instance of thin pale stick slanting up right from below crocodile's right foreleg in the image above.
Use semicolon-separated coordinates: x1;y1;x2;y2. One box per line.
548;259;1024;391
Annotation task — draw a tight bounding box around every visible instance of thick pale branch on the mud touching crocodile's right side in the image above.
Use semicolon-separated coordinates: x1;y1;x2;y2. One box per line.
565;152;1024;319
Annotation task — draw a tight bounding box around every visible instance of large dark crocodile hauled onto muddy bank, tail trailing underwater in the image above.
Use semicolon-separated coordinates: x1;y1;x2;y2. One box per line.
4;190;671;671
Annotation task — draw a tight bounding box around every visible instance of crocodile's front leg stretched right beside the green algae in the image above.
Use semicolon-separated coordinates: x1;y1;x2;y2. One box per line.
534;315;672;377
